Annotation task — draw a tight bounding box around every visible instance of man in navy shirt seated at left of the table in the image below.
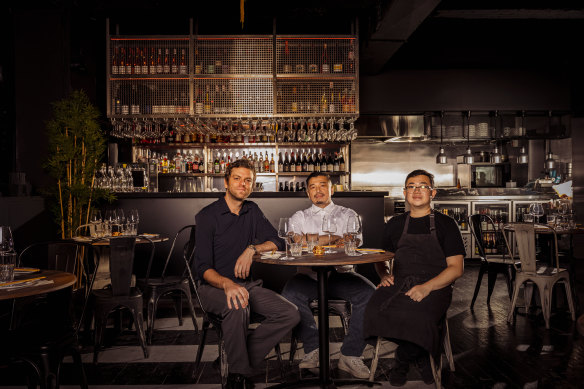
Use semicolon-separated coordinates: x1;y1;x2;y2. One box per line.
195;159;300;388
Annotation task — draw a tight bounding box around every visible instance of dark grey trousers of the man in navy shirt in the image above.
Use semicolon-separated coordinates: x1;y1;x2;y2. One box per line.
198;281;300;375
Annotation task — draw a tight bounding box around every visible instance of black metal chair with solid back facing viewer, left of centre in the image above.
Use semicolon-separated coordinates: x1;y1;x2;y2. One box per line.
91;236;154;363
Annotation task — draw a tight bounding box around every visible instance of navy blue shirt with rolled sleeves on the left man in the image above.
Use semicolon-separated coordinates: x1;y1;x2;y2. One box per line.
195;197;284;282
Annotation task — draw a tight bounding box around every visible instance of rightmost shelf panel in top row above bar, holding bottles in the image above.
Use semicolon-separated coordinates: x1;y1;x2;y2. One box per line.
276;36;357;75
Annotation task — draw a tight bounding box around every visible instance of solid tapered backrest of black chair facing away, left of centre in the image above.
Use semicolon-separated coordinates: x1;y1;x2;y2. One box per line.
110;236;136;296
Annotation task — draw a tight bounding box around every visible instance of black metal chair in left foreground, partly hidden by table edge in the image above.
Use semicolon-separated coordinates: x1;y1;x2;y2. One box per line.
2;241;95;388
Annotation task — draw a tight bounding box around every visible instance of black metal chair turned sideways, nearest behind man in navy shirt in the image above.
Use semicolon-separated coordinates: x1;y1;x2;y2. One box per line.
136;225;198;344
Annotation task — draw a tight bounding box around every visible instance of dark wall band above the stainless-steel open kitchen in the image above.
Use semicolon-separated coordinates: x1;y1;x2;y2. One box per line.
359;69;571;114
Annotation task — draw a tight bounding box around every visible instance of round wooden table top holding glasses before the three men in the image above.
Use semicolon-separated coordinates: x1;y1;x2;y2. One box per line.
253;247;393;266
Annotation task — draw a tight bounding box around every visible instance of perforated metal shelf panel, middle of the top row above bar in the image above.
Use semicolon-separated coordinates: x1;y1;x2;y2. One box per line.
194;35;273;75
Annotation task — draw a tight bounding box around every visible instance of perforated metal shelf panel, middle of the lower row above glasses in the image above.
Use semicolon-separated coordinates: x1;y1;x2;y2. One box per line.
193;78;274;117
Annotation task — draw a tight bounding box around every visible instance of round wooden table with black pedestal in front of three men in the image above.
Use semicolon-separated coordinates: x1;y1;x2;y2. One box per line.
254;248;393;388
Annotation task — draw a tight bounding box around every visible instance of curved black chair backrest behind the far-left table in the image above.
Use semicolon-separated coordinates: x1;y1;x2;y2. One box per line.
17;241;84;274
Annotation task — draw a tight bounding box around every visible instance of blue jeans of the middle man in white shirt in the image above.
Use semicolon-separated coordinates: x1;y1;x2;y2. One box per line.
282;271;375;357
